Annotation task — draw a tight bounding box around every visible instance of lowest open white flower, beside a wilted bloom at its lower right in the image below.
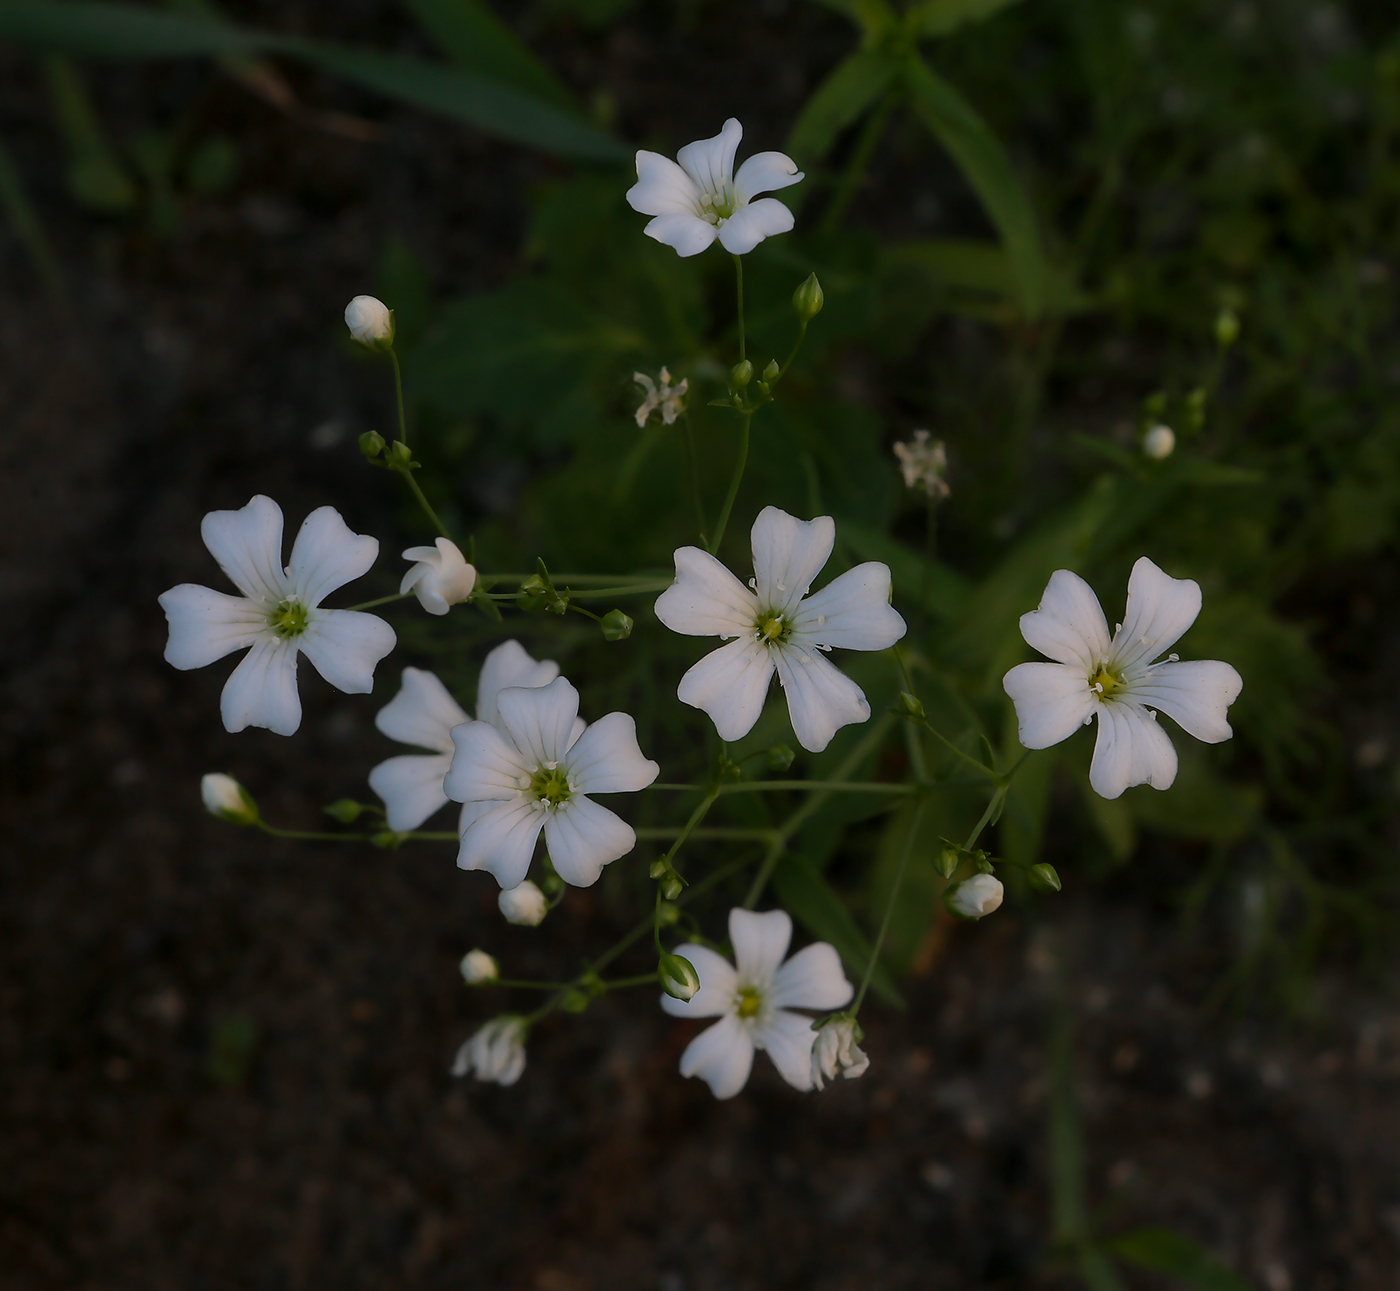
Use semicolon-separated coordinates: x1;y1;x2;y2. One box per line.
661;910;854;1098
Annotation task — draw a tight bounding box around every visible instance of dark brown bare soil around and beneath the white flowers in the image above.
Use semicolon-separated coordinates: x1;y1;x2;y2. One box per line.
0;0;1400;1291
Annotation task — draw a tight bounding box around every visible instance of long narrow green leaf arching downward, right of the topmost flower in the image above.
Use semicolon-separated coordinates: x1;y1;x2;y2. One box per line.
904;55;1049;318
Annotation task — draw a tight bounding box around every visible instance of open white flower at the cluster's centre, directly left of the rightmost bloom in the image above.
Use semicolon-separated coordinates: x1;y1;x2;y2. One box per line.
657;507;904;753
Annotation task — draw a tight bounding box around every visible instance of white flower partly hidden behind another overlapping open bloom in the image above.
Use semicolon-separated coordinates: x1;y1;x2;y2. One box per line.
370;641;559;830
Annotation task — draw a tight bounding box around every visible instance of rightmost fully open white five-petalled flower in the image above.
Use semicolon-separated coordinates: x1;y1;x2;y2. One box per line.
1002;556;1243;798
